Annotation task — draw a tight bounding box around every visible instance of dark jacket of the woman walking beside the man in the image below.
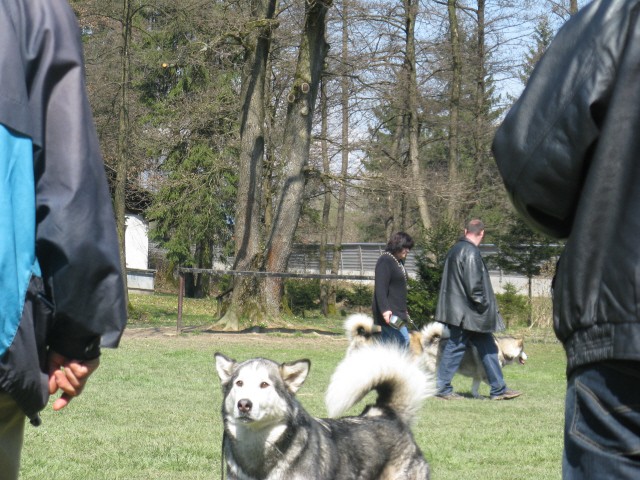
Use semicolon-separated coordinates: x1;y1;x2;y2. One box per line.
372;254;409;325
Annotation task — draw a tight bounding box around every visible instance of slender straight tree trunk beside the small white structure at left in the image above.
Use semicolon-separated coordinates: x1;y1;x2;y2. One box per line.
114;0;132;304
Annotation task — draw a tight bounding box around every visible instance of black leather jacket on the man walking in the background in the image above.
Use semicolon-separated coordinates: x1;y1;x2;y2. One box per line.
436;237;501;332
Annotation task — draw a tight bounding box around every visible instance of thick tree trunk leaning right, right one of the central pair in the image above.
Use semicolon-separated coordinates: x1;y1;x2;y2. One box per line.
264;0;331;317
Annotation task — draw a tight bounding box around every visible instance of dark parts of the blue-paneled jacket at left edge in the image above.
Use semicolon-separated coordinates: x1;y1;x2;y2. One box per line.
0;0;126;419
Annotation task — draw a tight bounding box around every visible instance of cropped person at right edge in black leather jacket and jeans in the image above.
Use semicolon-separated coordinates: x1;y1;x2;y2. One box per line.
493;0;640;480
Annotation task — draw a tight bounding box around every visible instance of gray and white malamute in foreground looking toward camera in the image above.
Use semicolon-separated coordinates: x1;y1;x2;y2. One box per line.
215;345;434;480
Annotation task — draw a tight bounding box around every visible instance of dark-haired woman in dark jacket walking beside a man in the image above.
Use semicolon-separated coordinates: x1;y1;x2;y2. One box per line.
372;232;413;347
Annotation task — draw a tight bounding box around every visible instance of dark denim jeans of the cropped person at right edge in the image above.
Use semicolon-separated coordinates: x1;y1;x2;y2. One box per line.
562;361;640;480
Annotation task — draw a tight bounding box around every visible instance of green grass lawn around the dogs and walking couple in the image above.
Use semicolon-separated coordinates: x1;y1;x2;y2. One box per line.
21;297;565;480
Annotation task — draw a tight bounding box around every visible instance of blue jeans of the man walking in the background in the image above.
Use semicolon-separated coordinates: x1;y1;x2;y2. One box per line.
436;325;507;396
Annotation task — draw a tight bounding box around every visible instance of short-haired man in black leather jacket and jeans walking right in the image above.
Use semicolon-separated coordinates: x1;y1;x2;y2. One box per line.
436;219;521;400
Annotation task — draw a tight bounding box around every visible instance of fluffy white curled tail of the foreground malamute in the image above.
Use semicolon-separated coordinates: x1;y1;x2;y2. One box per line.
325;343;435;423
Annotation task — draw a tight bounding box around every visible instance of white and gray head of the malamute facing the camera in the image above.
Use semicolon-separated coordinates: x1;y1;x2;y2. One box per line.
216;354;309;429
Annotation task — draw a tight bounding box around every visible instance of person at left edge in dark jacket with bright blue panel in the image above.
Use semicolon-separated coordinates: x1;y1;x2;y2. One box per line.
0;0;126;480
